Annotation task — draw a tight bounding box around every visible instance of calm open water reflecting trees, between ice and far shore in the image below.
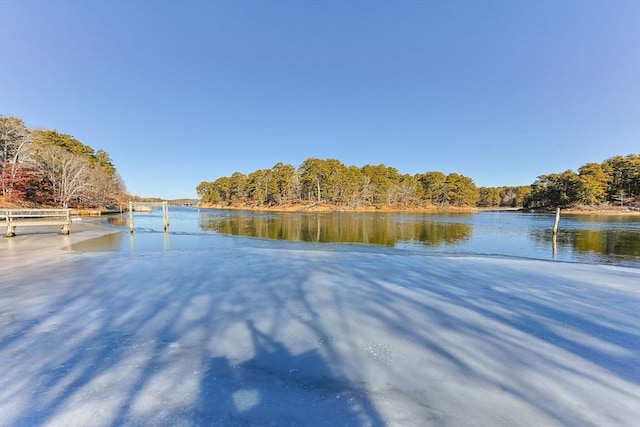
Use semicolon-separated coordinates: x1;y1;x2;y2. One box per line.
71;207;640;266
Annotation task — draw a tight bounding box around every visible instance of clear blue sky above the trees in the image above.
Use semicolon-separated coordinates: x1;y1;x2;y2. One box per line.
0;0;640;198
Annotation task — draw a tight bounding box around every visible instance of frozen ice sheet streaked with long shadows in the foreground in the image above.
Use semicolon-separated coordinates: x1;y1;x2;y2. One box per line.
0;245;640;427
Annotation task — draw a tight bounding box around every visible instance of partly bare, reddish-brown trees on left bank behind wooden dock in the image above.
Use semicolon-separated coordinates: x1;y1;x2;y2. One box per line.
0;116;125;208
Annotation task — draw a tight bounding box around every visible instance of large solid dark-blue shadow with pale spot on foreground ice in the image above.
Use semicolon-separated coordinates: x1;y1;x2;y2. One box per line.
194;320;384;426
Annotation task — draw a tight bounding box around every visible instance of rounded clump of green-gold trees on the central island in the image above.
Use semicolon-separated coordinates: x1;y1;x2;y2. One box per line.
196;158;502;209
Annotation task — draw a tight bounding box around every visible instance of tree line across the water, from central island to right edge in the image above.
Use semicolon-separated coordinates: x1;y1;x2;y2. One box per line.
196;154;640;209
